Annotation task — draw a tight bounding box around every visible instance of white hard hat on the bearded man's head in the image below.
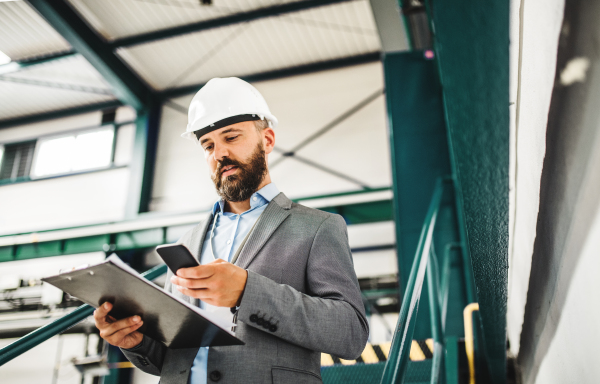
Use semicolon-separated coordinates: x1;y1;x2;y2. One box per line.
181;77;277;141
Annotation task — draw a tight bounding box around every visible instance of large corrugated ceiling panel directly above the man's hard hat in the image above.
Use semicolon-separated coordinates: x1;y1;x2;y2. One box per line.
118;0;380;89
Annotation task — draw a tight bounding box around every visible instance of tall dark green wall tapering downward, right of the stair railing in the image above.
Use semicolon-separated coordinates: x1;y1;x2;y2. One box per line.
429;0;509;383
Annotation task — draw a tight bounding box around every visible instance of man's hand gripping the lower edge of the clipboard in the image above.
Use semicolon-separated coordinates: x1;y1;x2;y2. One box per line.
94;302;144;349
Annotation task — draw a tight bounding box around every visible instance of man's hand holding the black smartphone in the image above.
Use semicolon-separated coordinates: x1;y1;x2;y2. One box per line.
171;259;248;308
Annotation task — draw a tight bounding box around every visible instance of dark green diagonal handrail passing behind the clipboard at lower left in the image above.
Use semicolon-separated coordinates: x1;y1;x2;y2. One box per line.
0;264;167;366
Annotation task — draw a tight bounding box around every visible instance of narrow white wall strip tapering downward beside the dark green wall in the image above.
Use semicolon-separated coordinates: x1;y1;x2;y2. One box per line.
507;0;564;356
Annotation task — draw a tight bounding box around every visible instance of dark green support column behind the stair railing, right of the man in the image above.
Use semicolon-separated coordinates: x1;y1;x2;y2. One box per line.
383;51;458;339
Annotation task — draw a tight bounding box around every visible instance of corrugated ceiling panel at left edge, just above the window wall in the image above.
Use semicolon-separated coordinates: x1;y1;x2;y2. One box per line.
0;56;115;119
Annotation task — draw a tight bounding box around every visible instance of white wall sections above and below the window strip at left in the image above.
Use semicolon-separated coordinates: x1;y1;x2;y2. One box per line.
0;107;135;235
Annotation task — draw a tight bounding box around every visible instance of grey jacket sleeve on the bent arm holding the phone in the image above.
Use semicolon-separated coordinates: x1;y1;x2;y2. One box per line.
238;215;369;359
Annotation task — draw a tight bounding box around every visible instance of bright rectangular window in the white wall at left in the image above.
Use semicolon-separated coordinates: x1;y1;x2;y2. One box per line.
31;126;115;178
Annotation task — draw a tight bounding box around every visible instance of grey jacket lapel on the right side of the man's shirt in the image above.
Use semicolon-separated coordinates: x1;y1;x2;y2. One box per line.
236;193;292;269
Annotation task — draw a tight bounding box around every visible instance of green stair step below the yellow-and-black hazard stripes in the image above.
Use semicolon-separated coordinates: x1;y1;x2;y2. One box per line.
321;359;431;384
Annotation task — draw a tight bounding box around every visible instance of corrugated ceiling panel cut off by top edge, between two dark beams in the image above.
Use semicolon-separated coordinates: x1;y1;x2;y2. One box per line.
69;0;308;40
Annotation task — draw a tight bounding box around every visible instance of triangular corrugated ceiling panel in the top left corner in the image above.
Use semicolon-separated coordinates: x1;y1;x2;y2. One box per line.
0;1;71;61
